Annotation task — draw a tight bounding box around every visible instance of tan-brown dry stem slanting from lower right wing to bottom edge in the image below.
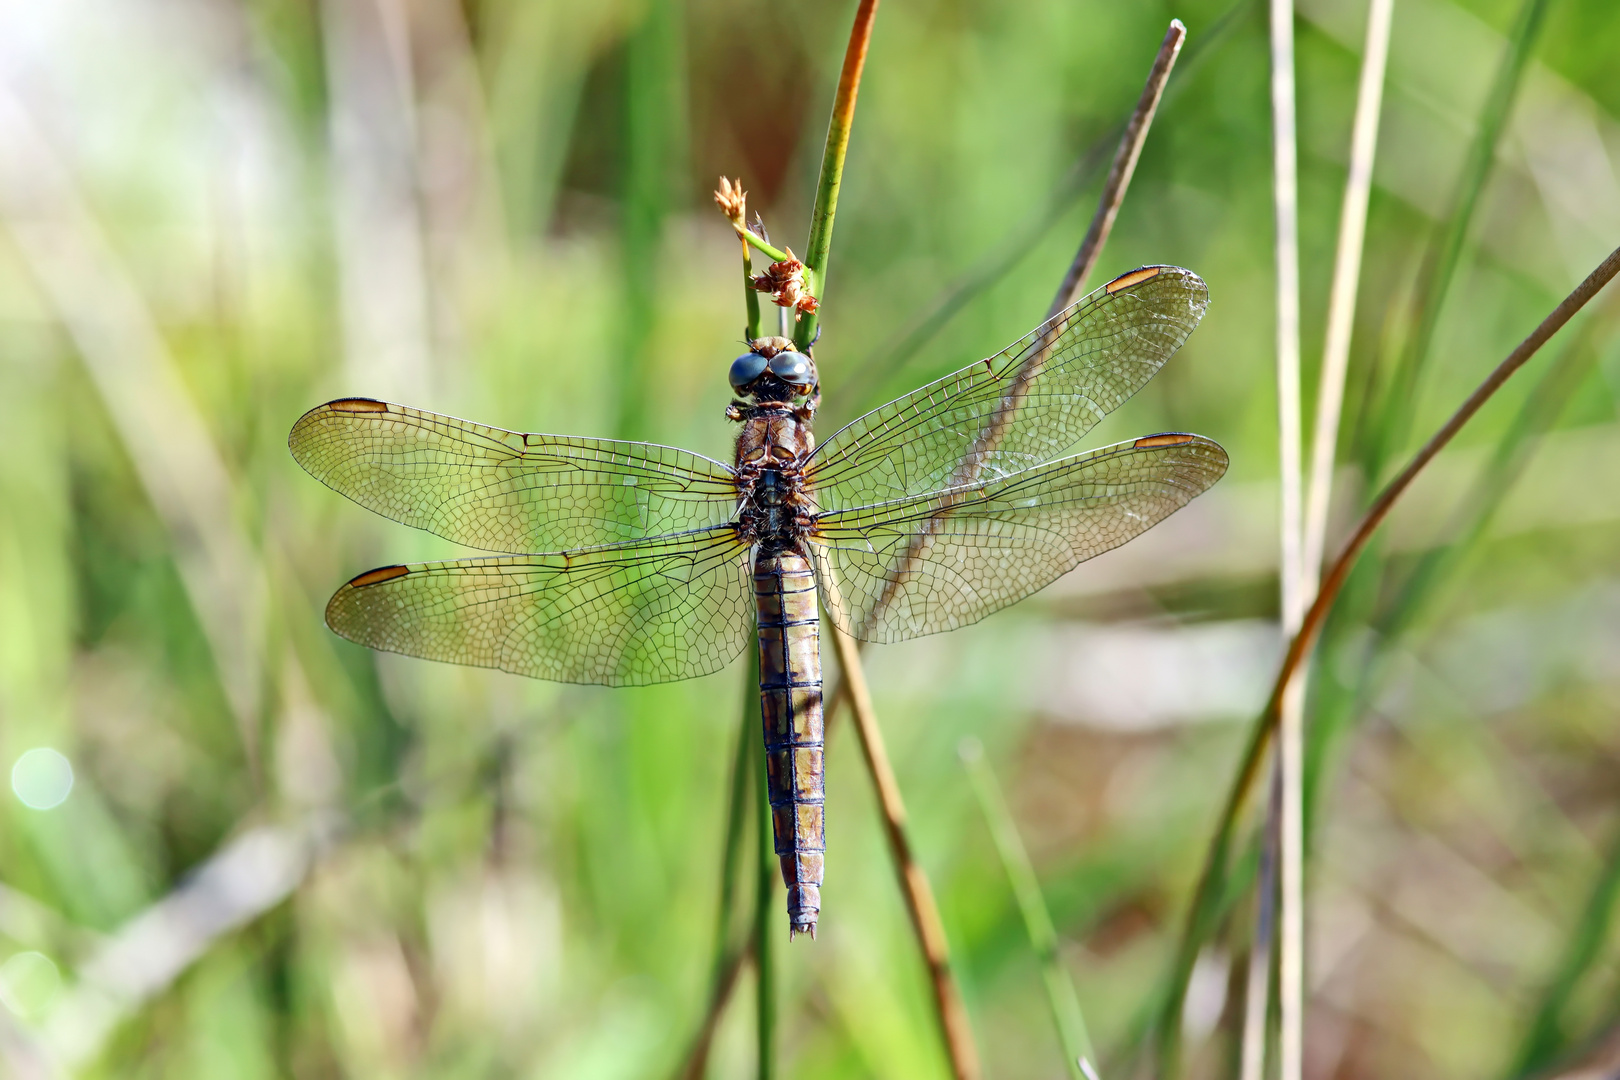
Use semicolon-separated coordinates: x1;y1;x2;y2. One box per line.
828;625;980;1080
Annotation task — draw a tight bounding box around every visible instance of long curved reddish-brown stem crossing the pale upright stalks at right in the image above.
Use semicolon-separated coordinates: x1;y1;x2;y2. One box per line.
1160;249;1620;1078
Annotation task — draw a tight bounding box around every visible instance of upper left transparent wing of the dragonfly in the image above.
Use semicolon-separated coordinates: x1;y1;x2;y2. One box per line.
287;398;737;554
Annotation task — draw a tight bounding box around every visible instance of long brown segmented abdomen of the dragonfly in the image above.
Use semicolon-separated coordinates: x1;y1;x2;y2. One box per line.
753;549;826;936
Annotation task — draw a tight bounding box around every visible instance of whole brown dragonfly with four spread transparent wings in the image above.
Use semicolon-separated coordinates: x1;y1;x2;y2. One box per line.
288;266;1226;936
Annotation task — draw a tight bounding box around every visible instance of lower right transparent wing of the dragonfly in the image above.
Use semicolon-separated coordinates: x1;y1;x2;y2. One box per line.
812;434;1226;643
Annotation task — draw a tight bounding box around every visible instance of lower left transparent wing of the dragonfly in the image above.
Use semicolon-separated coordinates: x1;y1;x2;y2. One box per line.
326;526;753;687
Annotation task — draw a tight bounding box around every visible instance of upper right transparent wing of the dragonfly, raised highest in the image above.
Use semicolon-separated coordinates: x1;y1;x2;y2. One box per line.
807;266;1209;510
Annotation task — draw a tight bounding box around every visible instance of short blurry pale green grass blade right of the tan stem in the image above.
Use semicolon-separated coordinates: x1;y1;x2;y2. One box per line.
957;738;1097;1080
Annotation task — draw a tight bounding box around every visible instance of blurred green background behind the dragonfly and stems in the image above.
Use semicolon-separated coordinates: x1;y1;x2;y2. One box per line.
0;0;1620;1080
